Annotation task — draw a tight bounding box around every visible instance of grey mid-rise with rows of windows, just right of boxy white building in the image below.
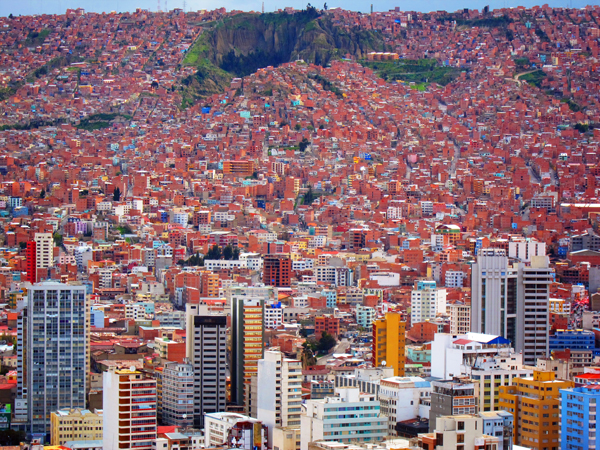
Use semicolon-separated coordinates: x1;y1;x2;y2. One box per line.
429;377;477;432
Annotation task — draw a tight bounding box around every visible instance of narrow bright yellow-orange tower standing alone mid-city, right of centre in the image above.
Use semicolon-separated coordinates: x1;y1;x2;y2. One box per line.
373;313;406;376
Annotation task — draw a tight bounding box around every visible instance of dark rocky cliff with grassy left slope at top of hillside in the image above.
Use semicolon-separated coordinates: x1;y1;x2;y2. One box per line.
178;7;385;103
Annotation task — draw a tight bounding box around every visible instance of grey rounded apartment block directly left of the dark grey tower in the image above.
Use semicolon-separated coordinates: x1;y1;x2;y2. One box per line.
161;362;193;427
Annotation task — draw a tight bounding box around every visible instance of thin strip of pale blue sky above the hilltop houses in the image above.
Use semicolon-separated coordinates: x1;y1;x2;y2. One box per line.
0;0;600;16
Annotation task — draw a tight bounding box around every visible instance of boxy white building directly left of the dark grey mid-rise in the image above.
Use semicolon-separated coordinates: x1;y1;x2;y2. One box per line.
379;377;431;436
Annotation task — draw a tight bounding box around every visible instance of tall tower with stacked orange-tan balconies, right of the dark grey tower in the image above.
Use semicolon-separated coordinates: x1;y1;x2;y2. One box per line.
229;297;265;410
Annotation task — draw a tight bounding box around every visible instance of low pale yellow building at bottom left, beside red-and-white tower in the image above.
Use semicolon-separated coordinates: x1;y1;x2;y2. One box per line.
50;409;102;445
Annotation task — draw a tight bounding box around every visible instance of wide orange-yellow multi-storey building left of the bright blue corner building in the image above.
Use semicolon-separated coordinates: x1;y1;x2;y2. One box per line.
498;370;574;450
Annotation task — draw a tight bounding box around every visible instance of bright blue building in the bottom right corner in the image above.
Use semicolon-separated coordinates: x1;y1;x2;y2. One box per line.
560;385;600;450
